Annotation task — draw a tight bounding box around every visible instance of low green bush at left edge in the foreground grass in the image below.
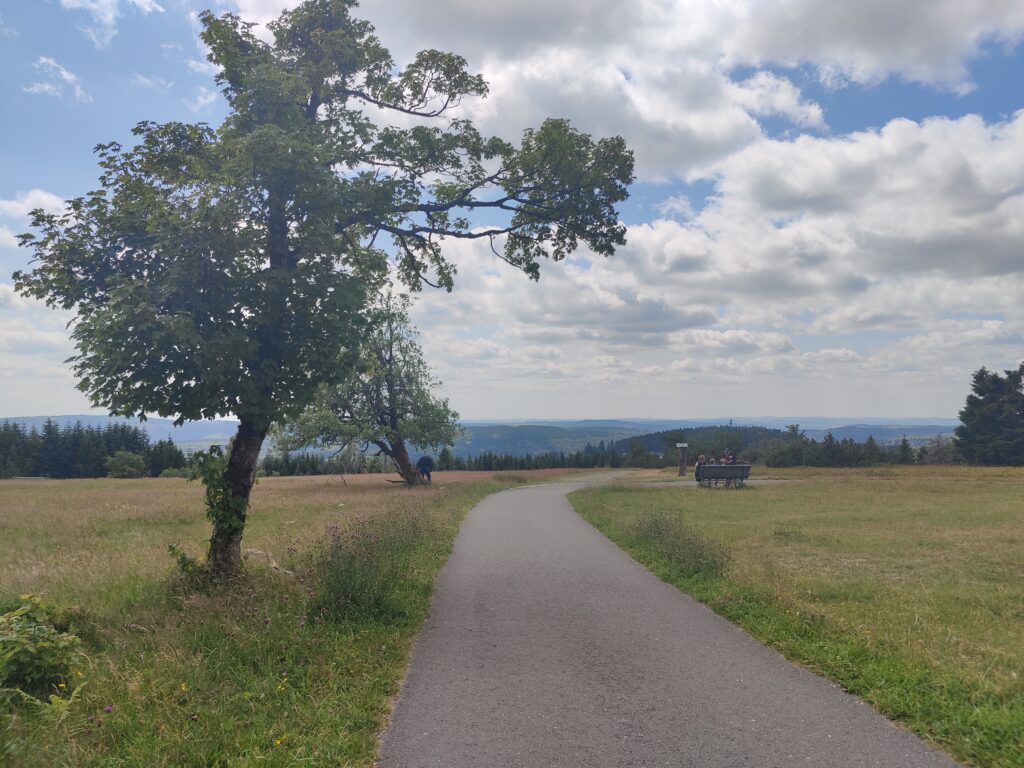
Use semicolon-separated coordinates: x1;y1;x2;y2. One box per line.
0;595;83;696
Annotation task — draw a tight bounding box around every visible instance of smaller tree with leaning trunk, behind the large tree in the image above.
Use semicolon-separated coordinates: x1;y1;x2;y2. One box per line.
278;291;461;485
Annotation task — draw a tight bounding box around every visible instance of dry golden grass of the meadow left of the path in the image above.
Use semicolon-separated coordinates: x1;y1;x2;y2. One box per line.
0;470;571;607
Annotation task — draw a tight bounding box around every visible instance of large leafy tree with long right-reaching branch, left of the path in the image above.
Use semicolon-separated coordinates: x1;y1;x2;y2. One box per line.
14;0;633;574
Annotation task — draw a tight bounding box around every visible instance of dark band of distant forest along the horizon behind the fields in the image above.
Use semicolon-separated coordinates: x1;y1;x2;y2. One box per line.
0;420;959;478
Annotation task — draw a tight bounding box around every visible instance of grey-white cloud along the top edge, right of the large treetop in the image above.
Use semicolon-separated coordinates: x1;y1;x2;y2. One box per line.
220;0;1024;180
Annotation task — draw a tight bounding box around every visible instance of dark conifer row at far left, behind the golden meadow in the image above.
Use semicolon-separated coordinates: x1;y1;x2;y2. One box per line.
0;419;187;478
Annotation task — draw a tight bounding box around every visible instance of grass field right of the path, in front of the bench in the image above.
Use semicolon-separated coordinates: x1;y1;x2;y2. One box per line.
570;467;1024;768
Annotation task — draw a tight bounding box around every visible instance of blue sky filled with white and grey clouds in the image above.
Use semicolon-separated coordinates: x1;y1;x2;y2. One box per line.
0;0;1024;419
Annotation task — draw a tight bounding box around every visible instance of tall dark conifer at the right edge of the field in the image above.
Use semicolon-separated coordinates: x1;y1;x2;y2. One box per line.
953;362;1024;467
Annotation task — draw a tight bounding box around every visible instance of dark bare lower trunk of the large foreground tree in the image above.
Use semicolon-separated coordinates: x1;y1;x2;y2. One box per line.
208;417;267;578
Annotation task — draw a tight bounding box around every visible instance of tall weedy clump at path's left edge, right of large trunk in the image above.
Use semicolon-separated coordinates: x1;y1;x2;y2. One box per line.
303;514;433;621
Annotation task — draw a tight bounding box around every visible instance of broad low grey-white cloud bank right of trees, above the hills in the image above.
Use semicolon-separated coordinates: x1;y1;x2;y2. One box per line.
399;105;1024;415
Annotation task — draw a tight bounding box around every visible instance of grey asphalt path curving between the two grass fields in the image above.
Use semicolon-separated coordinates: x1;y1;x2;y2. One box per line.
380;483;956;768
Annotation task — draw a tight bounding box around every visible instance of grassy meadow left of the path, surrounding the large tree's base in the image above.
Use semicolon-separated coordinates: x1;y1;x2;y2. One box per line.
0;471;577;768
